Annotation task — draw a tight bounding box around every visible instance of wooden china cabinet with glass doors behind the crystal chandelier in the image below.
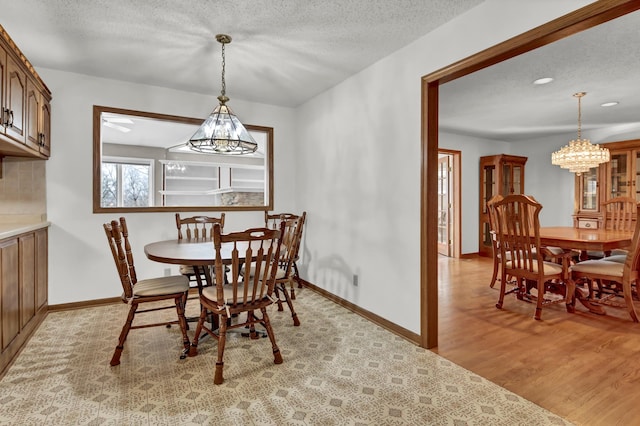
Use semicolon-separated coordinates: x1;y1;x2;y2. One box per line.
573;139;640;228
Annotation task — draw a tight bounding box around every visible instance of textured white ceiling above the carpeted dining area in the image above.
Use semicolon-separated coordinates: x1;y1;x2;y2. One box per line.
0;0;481;106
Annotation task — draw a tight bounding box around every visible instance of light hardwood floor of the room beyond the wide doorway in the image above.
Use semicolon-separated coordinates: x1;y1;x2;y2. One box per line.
433;257;640;425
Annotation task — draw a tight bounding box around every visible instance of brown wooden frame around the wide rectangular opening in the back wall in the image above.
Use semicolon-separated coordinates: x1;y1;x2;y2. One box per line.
93;105;273;213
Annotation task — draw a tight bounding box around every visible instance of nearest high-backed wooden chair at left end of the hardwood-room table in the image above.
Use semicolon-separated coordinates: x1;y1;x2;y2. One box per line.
494;195;574;320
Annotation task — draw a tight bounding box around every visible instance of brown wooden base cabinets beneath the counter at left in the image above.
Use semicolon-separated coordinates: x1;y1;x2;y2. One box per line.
0;228;48;373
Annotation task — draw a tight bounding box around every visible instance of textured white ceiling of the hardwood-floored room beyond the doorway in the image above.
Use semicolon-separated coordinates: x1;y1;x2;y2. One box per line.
440;12;640;144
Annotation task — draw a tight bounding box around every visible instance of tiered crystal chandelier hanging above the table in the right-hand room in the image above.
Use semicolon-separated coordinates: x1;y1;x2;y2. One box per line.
551;92;610;176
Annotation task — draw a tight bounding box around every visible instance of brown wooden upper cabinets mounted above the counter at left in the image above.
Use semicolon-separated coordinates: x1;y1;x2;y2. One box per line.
0;26;51;159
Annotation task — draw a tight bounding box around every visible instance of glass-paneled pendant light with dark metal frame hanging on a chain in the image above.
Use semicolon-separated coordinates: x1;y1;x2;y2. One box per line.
187;34;258;154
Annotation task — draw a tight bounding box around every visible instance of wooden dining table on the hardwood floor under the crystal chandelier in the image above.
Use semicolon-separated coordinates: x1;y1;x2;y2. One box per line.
540;226;633;315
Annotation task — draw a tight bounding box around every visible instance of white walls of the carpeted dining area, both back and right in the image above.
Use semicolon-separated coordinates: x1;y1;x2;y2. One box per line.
38;0;589;332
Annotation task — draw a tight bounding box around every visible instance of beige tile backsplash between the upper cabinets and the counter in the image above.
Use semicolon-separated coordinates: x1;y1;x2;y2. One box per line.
0;157;47;216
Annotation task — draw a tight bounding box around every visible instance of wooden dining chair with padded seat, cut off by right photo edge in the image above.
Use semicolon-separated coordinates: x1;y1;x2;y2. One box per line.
569;204;640;322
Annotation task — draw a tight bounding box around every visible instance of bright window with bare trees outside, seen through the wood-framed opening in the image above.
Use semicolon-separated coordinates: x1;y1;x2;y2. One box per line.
100;157;153;207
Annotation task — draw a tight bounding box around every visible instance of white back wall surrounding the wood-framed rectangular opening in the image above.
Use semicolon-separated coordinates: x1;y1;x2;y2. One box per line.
38;68;296;305
